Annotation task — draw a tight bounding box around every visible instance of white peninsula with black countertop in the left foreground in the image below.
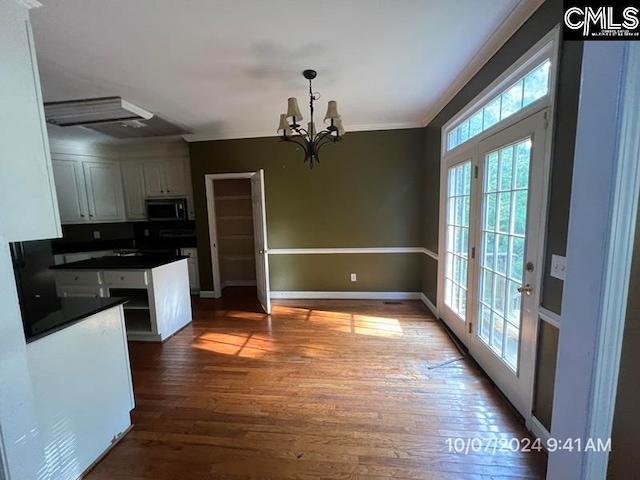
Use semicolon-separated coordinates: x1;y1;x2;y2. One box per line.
23;297;135;478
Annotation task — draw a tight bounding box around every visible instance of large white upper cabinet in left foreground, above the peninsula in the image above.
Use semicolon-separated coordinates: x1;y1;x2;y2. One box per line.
0;1;61;242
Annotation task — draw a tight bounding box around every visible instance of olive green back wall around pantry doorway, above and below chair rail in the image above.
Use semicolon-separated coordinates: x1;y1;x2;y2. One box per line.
189;129;424;292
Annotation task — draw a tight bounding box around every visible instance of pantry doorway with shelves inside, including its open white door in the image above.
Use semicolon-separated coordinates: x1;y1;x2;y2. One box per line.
205;170;271;313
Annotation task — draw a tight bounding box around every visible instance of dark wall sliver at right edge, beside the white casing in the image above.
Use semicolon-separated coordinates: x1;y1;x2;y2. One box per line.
607;194;640;480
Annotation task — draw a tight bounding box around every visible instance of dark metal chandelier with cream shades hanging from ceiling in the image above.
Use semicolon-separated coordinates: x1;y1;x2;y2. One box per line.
278;70;345;168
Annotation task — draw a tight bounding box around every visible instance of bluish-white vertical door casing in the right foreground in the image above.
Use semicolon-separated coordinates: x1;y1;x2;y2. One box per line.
547;42;637;480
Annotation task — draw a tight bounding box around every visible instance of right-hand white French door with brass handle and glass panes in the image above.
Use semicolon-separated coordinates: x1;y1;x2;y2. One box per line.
467;112;546;418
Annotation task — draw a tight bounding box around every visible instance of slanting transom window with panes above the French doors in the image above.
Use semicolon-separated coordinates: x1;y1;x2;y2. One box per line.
447;58;551;151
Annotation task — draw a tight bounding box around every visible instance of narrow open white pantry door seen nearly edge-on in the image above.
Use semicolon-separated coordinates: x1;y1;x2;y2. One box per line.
251;169;271;313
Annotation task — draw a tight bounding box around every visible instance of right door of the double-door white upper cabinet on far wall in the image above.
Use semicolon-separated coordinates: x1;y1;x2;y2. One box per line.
83;162;125;222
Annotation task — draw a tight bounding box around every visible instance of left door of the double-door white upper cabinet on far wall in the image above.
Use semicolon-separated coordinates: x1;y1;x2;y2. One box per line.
52;160;89;223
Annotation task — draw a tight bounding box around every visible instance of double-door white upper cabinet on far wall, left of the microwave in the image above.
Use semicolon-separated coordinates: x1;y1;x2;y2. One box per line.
53;158;126;224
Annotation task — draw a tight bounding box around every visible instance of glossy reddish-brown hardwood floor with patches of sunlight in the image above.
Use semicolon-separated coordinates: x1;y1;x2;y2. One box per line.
86;289;546;480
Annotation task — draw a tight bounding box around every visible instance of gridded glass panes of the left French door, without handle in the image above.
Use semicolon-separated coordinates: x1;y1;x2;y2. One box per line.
444;160;471;320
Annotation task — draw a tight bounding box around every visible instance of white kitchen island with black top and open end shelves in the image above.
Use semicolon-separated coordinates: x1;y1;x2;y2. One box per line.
52;255;192;342
